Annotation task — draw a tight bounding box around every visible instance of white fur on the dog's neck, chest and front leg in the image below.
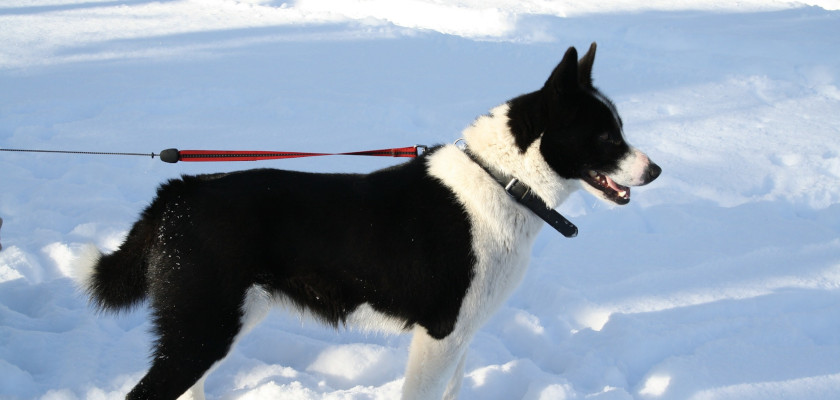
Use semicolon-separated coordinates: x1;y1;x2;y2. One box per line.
403;105;579;400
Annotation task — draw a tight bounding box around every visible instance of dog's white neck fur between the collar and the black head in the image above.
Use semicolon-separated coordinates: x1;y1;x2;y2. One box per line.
462;104;580;208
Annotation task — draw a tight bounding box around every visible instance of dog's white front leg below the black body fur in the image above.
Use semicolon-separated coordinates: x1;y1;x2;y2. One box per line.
402;326;470;400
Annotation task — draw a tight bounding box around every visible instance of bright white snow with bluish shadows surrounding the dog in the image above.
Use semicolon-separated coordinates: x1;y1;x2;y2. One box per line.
0;0;840;400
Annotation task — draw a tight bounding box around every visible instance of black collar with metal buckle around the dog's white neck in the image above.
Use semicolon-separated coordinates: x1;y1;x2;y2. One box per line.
462;147;577;238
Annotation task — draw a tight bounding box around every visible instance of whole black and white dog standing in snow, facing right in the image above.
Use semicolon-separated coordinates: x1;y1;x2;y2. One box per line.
75;43;661;399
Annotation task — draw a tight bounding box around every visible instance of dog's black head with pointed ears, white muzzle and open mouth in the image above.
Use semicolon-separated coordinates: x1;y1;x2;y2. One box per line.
508;43;662;204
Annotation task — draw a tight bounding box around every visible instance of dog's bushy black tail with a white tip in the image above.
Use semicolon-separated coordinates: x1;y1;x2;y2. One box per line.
80;219;153;311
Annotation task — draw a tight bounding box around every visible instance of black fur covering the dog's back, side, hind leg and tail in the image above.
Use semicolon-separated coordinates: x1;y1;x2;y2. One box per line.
92;149;474;398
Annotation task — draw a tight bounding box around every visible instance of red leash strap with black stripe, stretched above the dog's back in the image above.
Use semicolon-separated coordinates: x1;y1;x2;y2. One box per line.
160;145;426;163
